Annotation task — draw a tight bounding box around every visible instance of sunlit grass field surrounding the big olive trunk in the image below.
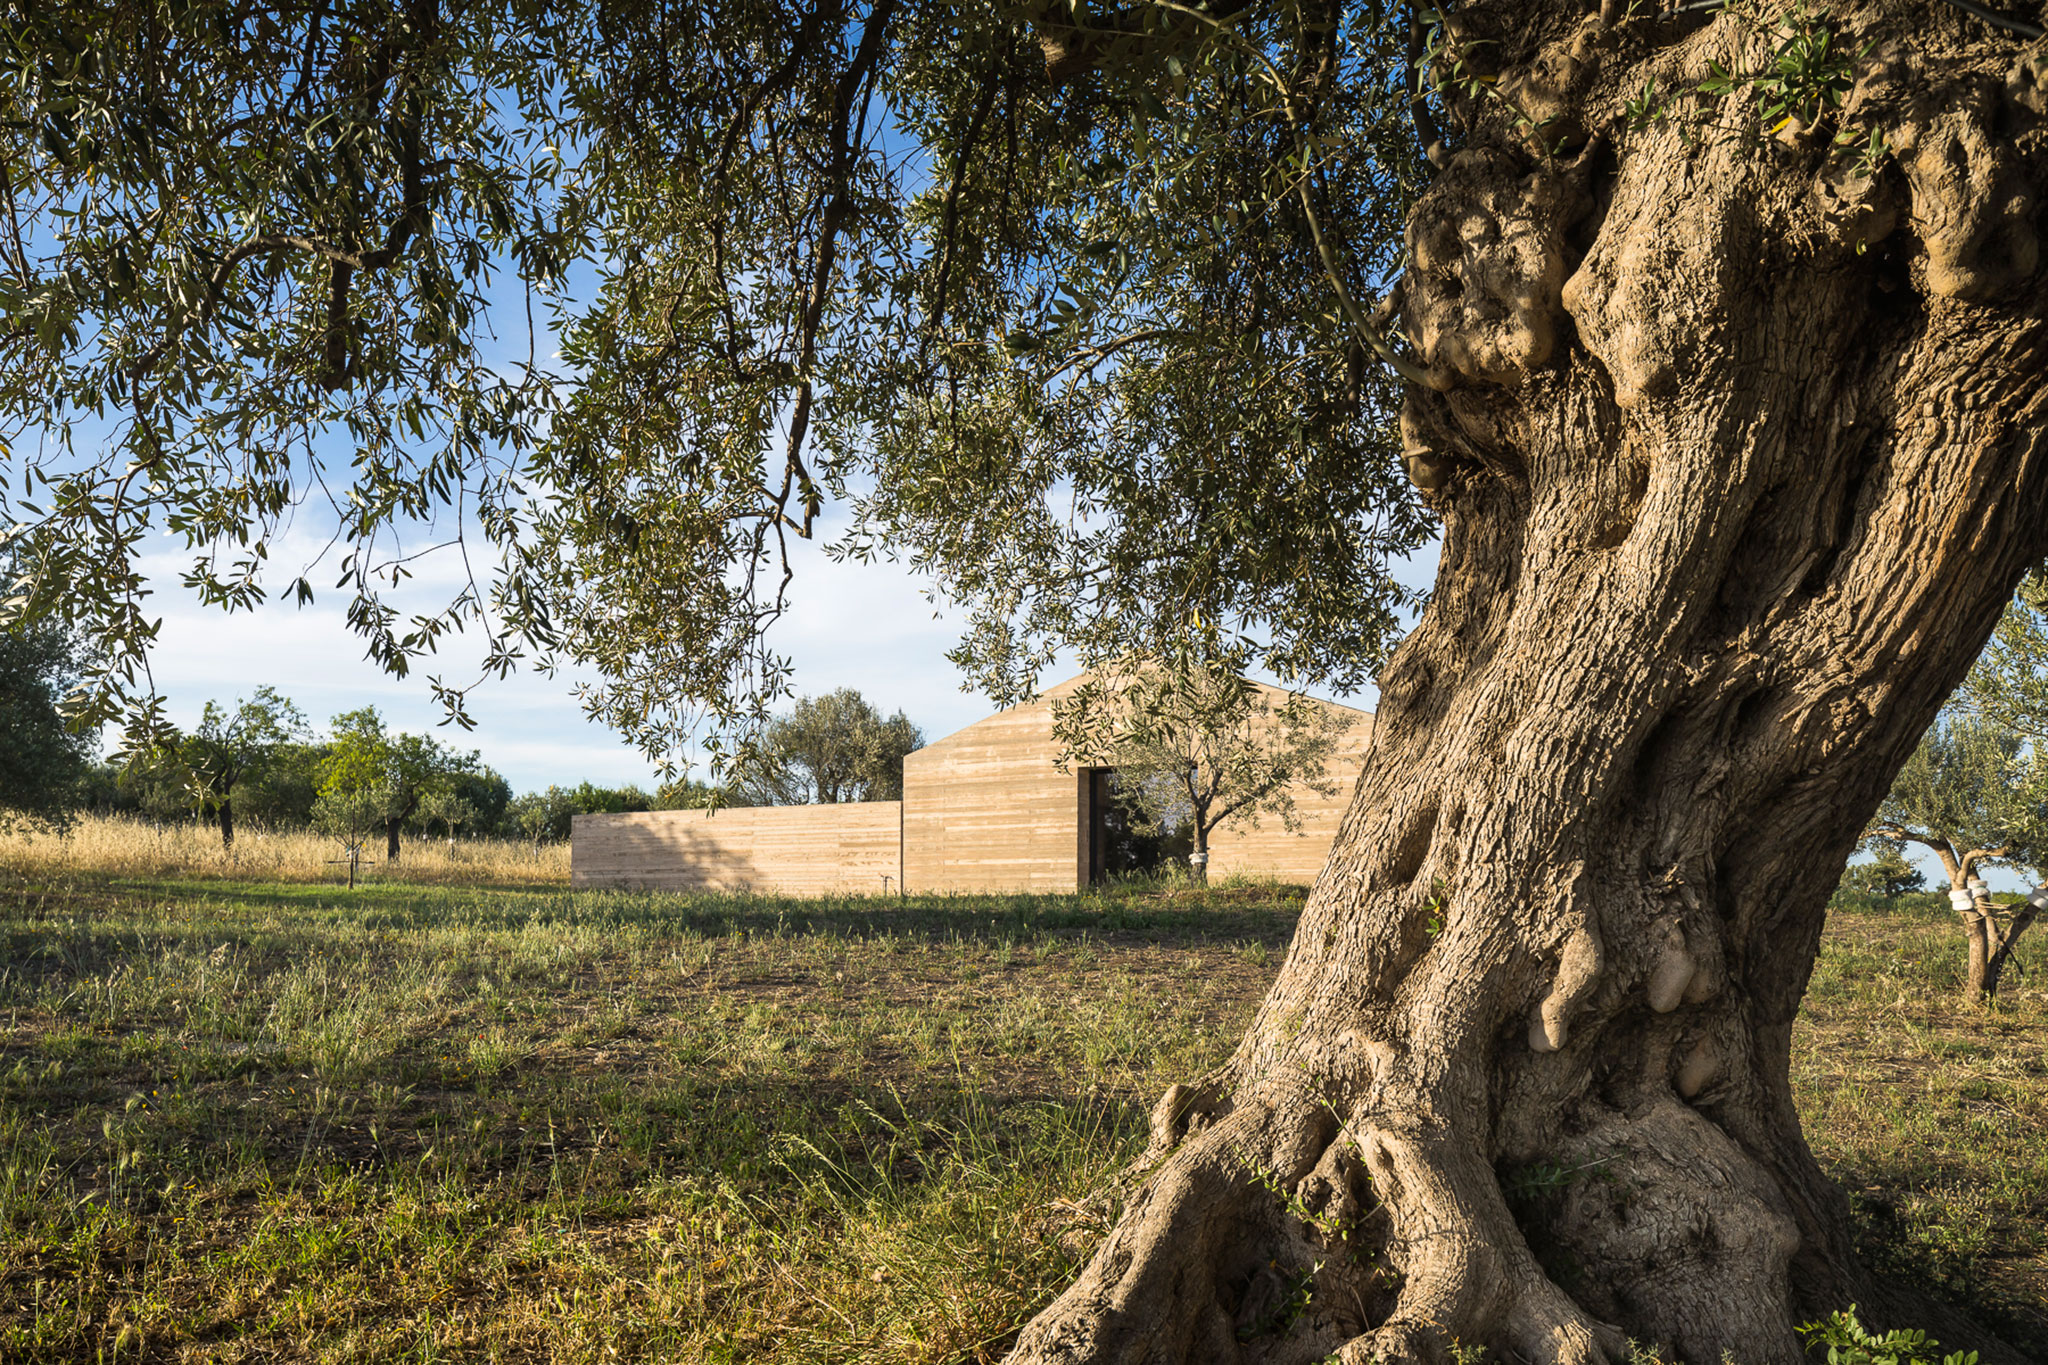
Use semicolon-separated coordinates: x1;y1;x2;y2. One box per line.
0;864;2048;1365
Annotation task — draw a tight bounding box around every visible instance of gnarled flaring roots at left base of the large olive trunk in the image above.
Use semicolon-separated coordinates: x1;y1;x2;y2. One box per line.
1010;1093;1626;1365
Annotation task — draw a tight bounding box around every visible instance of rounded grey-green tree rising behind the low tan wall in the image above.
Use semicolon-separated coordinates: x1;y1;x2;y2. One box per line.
731;688;924;806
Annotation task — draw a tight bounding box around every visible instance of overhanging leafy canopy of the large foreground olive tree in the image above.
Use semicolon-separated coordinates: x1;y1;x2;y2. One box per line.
0;0;1430;773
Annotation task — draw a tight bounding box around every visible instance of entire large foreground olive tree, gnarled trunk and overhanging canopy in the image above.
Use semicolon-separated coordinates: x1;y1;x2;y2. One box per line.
0;0;2048;1365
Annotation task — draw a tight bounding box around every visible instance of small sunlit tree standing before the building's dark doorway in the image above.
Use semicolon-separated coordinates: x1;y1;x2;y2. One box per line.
1055;665;1352;882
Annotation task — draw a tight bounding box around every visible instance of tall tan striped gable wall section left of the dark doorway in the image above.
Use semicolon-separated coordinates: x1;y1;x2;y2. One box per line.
903;679;1087;894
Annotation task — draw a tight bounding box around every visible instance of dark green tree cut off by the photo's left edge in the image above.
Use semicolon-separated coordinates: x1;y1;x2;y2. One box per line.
0;624;96;827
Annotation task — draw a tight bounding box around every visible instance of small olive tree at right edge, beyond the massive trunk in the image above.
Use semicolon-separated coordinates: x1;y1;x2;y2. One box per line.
1870;714;2048;1005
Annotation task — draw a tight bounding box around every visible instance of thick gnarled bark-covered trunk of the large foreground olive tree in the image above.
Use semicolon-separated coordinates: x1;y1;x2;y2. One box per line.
1010;0;2048;1365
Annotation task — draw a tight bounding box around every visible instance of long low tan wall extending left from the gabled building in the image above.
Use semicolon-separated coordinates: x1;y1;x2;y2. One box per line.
569;800;903;896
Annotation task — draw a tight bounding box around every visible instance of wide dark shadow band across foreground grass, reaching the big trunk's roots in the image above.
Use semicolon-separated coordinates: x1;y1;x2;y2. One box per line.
0;1038;1147;1242
